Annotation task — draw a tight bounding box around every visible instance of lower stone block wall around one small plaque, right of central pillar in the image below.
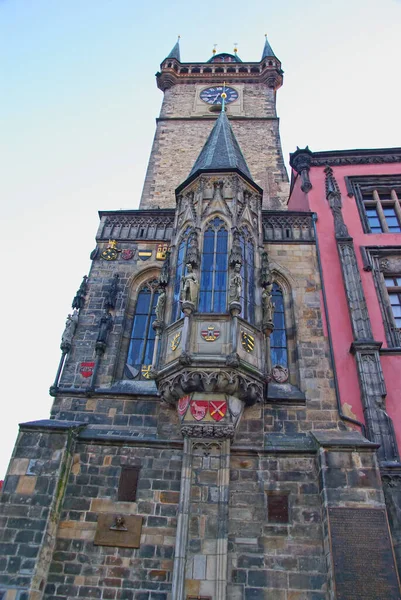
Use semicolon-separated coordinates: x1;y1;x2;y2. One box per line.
227;450;327;600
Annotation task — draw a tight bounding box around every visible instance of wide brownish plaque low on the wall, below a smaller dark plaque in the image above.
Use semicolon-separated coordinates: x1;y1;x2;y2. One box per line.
93;513;142;548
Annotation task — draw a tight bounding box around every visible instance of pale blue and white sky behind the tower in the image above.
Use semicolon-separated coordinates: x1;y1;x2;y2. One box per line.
0;0;401;479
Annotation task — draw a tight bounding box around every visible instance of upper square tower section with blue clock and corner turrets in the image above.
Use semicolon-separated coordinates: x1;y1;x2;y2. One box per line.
140;39;288;209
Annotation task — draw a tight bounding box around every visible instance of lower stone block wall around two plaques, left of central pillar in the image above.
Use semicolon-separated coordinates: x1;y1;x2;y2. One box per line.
44;443;182;600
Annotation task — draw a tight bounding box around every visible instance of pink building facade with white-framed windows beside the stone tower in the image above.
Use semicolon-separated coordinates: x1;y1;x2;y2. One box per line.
288;148;401;559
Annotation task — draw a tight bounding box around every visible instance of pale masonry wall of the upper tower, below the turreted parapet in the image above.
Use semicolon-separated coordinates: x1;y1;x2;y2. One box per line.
140;79;289;209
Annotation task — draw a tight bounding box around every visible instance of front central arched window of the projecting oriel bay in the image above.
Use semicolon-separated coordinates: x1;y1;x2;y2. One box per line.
199;217;228;313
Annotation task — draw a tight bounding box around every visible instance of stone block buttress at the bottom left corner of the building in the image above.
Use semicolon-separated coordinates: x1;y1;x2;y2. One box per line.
0;427;78;600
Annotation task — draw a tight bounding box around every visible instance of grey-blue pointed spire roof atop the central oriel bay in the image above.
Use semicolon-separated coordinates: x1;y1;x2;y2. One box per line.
177;110;260;192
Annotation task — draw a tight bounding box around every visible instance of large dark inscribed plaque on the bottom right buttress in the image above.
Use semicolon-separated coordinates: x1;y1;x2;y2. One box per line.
329;508;401;600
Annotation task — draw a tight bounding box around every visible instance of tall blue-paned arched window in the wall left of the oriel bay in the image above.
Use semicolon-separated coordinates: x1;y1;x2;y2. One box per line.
127;281;159;378
